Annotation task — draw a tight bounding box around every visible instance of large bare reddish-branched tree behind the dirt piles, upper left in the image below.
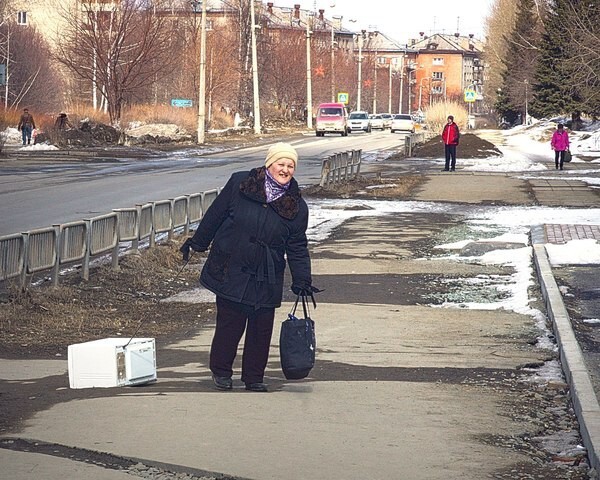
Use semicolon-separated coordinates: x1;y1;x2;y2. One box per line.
56;0;173;124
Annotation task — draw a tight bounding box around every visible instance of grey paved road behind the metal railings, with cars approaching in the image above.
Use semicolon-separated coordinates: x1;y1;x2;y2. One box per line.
0;131;404;235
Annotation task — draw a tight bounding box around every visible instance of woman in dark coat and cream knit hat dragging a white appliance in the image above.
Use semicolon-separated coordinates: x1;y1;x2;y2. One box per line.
181;143;318;392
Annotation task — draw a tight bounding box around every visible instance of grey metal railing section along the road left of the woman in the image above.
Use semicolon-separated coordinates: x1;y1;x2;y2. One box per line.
0;188;221;288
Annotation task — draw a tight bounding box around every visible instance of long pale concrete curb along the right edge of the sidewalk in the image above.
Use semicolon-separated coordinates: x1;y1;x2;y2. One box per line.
532;236;600;472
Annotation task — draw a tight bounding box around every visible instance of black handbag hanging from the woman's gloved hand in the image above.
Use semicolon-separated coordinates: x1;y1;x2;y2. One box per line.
279;295;317;380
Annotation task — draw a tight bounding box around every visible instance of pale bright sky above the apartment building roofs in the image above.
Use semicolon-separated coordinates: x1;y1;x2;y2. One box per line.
265;0;495;44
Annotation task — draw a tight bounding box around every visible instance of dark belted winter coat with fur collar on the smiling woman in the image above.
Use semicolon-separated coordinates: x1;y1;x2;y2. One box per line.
191;167;312;309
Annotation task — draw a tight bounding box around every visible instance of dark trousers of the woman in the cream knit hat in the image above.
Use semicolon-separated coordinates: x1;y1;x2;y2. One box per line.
210;297;275;383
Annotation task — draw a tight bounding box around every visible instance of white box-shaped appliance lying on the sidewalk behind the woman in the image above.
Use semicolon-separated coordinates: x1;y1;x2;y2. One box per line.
68;338;157;388
